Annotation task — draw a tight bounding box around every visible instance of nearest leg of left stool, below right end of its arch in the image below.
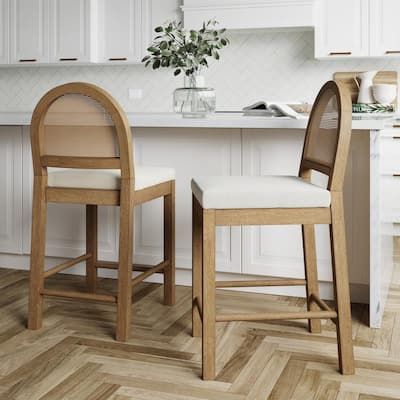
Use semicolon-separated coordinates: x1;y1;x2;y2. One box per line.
116;183;133;342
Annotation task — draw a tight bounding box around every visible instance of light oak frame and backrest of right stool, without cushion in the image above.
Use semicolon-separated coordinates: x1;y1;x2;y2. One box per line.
192;81;354;380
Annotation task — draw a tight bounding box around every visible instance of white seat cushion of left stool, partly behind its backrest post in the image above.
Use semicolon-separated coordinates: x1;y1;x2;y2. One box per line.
48;165;175;190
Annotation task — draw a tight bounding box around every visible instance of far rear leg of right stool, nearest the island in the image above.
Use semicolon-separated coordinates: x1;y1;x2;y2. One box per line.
302;225;321;333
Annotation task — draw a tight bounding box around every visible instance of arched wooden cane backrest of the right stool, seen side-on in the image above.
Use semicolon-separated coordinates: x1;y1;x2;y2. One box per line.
300;81;351;191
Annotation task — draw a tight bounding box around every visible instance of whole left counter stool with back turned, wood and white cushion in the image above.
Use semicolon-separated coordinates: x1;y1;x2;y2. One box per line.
28;82;175;341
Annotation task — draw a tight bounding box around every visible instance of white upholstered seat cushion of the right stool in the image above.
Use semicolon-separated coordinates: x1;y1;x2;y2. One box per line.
192;176;331;209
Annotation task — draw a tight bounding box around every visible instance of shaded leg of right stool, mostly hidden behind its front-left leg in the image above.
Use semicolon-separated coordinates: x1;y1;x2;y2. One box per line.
192;196;203;337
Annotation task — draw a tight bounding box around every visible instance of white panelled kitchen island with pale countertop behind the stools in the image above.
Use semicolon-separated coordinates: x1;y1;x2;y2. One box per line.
0;112;400;327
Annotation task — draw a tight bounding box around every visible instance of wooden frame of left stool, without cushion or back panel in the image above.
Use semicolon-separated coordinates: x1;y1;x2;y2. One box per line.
28;82;175;341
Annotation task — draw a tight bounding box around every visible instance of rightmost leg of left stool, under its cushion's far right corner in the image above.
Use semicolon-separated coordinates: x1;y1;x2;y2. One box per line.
164;182;175;306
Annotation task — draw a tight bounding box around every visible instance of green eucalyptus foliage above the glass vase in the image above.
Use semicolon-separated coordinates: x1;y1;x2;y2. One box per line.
142;20;229;76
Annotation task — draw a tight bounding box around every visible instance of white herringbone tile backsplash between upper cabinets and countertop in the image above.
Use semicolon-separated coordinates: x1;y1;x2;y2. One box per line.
0;31;400;112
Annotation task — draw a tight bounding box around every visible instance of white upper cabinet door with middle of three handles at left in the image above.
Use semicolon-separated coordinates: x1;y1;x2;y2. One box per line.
50;0;95;63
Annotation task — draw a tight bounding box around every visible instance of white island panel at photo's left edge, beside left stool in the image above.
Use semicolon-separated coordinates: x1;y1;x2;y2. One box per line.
0;126;22;254
